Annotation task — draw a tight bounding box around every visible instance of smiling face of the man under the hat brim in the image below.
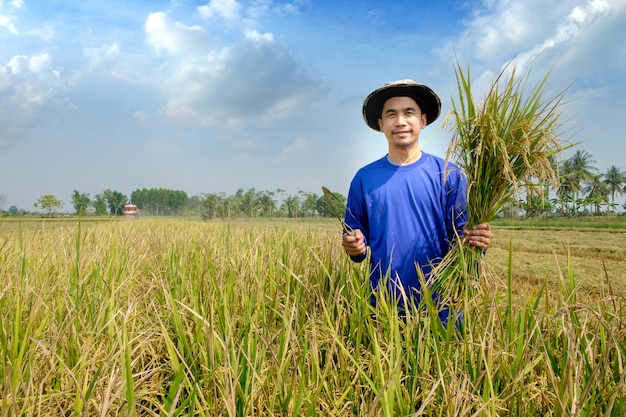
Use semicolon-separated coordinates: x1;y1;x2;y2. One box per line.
378;97;426;148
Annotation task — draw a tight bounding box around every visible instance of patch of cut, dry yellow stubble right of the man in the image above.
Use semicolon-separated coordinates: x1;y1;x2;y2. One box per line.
487;228;626;304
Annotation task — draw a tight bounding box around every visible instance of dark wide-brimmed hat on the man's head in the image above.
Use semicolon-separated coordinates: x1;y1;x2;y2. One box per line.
363;80;441;131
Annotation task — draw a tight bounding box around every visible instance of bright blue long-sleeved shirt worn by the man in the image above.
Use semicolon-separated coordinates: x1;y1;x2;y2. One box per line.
345;153;467;303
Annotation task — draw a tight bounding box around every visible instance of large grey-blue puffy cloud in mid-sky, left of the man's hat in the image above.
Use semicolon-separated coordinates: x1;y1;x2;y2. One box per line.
189;38;326;128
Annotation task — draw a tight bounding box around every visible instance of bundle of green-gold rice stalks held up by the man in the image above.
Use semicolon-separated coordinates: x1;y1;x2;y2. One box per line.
430;63;568;305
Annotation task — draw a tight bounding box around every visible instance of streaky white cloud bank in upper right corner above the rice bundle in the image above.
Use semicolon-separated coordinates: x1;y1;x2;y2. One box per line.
441;0;626;97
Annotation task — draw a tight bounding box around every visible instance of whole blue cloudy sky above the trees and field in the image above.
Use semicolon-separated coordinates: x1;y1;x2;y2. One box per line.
0;0;626;211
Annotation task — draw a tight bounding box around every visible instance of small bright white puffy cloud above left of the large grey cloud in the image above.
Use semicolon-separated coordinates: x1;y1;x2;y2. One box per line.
144;12;206;54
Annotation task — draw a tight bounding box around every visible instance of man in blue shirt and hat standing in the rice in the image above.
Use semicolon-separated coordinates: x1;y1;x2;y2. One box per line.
343;80;492;320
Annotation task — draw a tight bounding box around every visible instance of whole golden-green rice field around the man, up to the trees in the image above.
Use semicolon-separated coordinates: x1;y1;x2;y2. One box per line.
0;219;626;416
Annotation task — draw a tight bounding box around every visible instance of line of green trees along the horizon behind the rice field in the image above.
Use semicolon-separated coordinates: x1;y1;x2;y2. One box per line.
0;150;626;219
